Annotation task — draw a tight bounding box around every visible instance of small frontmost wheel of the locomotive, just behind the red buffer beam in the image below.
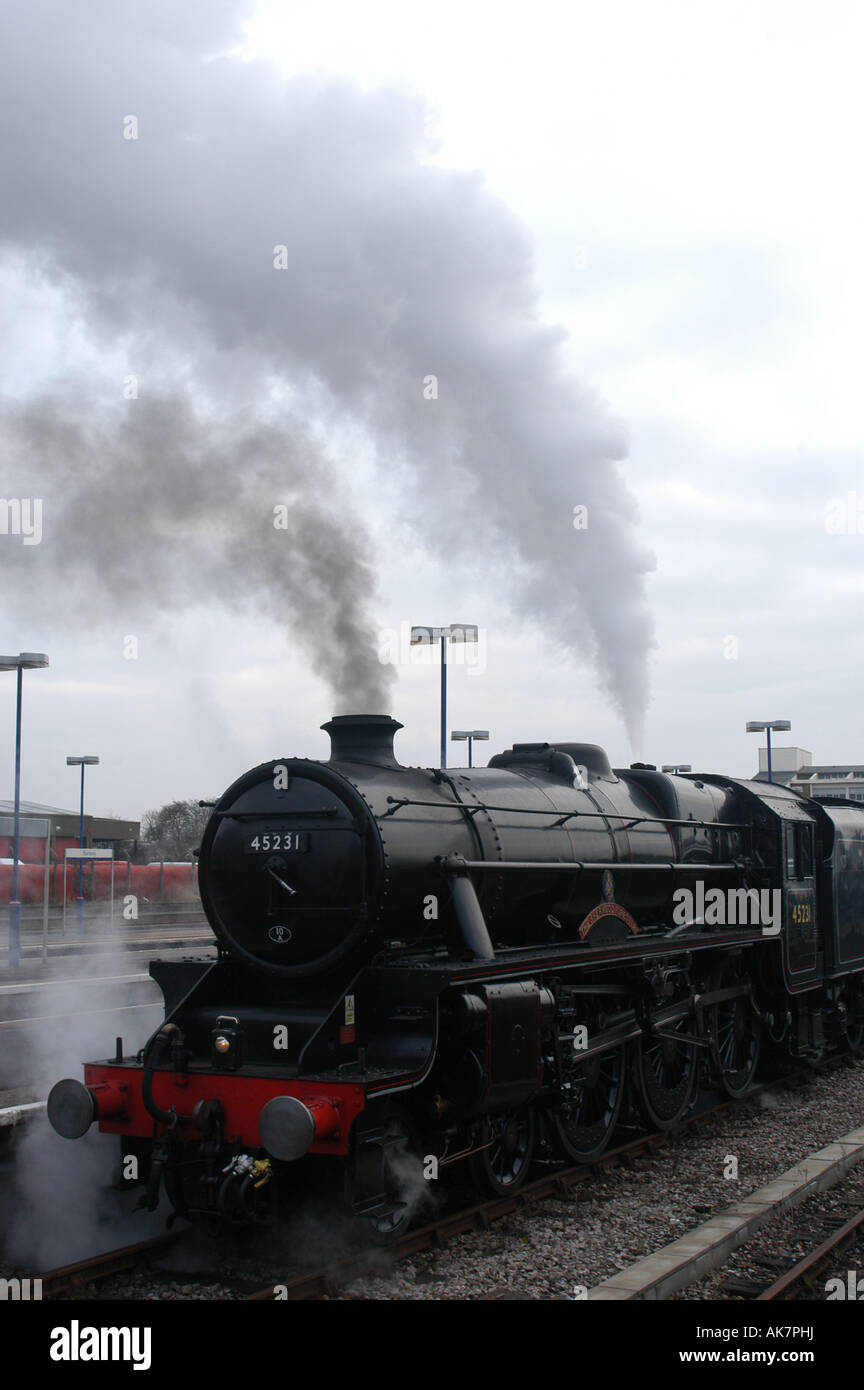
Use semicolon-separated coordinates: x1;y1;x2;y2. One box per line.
344;1112;429;1245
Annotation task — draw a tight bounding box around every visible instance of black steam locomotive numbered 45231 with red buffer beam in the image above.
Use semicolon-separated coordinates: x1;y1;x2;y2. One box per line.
47;716;864;1238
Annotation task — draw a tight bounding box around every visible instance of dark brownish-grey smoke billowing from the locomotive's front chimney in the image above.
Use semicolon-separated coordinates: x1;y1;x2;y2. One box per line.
0;391;392;710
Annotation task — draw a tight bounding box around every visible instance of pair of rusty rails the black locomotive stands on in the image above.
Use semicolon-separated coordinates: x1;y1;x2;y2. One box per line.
42;1055;846;1302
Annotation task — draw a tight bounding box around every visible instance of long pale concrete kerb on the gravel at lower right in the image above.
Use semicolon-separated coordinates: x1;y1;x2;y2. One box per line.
588;1126;864;1301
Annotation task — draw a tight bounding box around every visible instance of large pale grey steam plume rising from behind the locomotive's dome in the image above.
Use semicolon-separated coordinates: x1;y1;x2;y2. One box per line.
0;0;651;744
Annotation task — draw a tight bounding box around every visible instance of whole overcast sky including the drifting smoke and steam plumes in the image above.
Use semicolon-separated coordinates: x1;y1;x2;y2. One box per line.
0;0;864;817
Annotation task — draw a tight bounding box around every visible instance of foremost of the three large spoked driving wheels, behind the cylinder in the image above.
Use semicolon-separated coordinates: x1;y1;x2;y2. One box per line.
550;1047;625;1163
